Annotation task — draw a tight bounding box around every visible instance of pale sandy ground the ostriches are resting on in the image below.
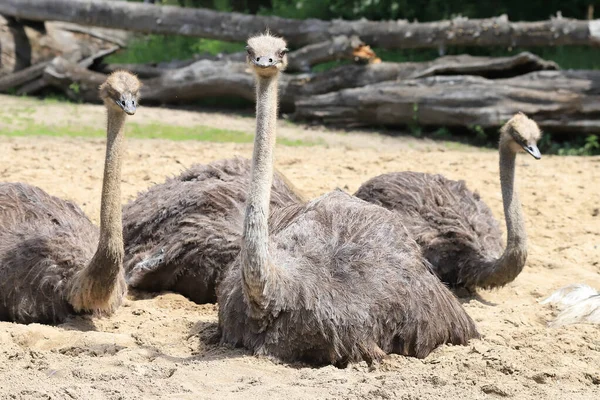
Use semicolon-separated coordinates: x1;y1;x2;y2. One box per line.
0;96;600;400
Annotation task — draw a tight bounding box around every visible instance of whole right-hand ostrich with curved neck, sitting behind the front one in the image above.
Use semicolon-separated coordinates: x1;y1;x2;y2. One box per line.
355;113;541;293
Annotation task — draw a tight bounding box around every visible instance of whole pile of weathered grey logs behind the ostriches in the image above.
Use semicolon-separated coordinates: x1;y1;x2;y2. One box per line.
0;0;600;133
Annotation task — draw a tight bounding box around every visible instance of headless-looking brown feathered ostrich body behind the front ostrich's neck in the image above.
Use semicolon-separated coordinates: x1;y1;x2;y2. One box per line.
123;157;303;303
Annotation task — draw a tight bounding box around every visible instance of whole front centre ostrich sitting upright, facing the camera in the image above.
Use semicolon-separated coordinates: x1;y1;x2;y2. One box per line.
217;34;478;367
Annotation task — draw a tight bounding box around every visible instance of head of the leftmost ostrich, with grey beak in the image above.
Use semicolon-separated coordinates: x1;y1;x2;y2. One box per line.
100;71;142;115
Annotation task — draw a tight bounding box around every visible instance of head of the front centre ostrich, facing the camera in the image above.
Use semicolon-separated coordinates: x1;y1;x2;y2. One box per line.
246;32;288;78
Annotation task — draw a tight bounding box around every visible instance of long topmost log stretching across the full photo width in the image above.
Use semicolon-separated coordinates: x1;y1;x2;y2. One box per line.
0;0;600;49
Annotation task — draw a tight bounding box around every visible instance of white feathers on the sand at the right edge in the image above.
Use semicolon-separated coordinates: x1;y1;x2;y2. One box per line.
541;284;600;327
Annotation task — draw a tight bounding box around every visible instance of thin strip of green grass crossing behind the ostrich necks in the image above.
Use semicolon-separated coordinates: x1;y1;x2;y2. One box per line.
0;123;322;147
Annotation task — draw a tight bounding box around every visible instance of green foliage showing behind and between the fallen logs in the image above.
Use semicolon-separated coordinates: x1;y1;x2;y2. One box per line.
116;0;600;71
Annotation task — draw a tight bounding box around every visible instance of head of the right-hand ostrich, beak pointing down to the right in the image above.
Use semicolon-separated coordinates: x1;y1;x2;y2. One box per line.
500;112;542;160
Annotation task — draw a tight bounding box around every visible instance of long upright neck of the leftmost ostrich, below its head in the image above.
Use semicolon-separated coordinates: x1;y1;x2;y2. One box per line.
89;108;126;282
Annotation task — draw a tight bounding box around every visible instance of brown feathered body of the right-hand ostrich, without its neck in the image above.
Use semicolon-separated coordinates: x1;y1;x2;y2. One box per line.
355;172;503;285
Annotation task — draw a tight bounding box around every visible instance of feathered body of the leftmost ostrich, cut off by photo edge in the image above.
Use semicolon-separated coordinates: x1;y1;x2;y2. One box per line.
0;183;99;323
